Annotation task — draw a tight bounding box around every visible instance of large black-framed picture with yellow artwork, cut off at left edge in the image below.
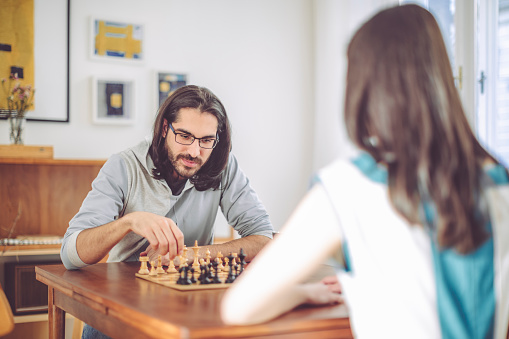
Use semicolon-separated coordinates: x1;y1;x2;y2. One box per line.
0;0;70;122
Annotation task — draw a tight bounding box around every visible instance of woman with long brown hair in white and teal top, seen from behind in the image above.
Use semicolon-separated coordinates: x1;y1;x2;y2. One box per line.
221;5;509;338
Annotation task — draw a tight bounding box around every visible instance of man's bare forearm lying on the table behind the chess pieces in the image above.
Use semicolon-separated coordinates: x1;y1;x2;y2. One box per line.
183;235;271;262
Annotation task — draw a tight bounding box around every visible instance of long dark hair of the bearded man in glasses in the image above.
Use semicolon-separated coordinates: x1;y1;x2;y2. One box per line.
149;85;231;191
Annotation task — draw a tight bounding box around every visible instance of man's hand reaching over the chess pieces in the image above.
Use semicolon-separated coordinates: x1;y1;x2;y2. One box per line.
124;212;184;259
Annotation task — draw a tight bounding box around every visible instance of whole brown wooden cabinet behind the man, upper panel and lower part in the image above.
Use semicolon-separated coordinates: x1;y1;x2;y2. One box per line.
0;157;105;320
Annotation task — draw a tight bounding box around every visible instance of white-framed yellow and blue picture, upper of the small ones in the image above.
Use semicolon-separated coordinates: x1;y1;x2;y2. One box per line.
90;18;145;64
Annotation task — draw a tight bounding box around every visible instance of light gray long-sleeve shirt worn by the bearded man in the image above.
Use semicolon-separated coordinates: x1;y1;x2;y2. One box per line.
60;140;273;269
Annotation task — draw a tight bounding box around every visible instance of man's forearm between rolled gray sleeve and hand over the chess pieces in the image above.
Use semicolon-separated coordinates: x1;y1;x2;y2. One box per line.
76;218;129;265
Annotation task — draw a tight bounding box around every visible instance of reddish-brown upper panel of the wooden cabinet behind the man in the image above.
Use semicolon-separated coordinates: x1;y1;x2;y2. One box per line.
0;158;105;238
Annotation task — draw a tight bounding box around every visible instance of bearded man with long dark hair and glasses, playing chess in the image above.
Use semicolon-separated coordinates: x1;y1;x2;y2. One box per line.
60;86;273;269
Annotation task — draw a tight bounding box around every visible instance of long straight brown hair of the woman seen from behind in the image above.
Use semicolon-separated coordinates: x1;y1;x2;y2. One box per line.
345;5;496;253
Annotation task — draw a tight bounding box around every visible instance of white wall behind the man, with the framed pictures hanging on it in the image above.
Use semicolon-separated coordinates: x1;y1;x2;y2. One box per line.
0;0;313;232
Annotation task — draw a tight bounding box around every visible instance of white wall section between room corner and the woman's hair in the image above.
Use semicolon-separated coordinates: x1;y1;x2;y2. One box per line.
312;0;398;172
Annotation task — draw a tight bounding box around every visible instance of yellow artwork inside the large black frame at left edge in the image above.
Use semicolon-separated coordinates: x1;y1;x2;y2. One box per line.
0;0;35;109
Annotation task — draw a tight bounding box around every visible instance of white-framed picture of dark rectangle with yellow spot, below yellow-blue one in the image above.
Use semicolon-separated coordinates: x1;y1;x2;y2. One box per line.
92;77;135;125
